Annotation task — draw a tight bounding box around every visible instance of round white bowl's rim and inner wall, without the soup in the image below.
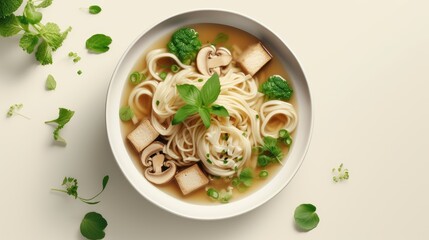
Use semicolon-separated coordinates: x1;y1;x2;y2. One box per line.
106;10;313;220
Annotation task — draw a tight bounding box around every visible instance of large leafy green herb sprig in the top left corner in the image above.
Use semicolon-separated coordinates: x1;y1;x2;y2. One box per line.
0;0;71;65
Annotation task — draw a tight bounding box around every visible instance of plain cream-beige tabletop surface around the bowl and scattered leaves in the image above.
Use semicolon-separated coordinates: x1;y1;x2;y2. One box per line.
0;0;429;240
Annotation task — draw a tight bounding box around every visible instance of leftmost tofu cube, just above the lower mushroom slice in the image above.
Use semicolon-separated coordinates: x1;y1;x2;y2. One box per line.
127;119;159;152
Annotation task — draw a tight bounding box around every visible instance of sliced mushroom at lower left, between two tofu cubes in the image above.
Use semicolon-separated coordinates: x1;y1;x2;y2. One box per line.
140;141;177;184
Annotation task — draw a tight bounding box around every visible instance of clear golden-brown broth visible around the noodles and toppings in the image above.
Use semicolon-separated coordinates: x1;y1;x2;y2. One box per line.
121;24;296;204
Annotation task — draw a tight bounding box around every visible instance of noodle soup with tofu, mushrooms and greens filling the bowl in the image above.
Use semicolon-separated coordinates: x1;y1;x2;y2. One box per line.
120;24;298;204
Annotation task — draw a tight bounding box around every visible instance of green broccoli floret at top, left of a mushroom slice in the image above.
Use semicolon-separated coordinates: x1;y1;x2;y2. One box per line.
167;28;201;65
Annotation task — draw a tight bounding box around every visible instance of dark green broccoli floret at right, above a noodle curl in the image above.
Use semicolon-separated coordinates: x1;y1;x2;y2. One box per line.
260;75;293;100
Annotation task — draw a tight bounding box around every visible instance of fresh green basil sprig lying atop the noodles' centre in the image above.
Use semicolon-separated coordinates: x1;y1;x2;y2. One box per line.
172;73;229;128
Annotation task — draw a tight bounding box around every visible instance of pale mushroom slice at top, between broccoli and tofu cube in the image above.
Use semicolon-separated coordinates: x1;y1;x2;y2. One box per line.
196;45;232;76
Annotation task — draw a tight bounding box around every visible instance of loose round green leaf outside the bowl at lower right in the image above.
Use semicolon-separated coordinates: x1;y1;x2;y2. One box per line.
294;204;320;231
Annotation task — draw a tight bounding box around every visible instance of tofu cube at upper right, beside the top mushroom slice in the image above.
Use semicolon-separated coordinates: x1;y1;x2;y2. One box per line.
237;42;272;76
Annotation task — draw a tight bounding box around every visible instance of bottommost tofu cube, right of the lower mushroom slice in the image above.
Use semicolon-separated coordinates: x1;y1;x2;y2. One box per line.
175;164;209;195
